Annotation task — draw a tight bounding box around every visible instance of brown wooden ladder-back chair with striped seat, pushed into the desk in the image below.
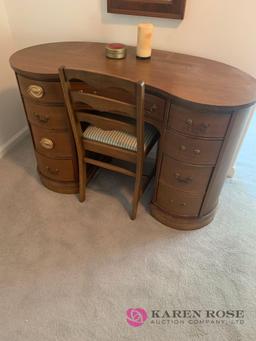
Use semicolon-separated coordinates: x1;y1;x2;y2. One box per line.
59;67;159;219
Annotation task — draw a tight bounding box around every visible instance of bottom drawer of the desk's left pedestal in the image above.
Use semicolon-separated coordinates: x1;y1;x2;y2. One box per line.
36;153;75;181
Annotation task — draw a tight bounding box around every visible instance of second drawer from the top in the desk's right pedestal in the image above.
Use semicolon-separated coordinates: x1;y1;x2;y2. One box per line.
164;131;222;165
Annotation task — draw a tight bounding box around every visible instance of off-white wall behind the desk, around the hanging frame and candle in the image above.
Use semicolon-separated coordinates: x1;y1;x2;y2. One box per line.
5;0;256;76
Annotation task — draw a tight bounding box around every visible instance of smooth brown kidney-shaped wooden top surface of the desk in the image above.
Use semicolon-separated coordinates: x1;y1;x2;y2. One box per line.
10;42;256;108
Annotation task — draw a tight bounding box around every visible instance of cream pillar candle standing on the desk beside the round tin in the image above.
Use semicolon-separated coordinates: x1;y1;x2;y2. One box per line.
137;24;154;58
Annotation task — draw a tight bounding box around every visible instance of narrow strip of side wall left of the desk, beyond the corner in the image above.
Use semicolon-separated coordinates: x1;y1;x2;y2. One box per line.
0;0;26;157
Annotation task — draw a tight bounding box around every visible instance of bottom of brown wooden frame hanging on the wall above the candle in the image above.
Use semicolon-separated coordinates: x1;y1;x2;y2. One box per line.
108;0;186;19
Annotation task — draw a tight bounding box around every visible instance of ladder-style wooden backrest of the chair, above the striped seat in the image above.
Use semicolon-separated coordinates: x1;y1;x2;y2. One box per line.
59;67;145;154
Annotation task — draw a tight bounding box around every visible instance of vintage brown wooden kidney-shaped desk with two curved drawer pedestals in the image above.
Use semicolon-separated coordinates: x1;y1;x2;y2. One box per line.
10;42;256;230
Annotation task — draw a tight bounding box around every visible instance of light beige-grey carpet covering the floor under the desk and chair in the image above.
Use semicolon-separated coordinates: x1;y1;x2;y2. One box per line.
0;133;256;341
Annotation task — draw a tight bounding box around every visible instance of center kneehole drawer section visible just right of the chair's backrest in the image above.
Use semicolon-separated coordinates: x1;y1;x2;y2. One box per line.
145;93;166;121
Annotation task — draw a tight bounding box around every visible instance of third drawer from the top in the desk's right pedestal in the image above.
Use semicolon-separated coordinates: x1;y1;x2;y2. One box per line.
160;155;213;194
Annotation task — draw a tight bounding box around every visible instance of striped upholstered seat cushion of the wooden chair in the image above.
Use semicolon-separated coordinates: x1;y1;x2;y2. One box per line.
83;124;158;152
